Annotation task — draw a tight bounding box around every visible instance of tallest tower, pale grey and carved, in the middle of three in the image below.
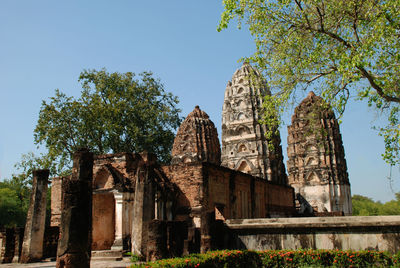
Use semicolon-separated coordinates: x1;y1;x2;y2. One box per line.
222;63;286;184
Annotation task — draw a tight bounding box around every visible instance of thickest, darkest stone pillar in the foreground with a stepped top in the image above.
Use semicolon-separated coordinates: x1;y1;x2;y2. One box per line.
57;149;93;268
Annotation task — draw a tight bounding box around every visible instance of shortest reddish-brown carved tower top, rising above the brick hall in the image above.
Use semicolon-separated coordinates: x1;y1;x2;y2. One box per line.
172;106;221;165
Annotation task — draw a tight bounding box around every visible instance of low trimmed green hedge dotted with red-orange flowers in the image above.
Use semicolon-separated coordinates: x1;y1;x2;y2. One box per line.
132;249;400;268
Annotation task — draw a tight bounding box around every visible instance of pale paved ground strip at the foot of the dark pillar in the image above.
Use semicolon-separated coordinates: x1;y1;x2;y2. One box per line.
0;259;132;268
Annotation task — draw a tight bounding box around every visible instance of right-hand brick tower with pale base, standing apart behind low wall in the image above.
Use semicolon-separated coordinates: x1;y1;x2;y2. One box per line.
287;92;352;215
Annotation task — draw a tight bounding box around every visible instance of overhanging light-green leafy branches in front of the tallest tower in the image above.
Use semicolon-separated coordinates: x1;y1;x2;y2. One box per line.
218;0;400;165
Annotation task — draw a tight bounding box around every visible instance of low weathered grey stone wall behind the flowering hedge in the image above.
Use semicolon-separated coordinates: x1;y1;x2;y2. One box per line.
224;216;400;253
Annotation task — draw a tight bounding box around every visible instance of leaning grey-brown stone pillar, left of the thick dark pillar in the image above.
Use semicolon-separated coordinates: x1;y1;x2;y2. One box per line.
20;169;49;263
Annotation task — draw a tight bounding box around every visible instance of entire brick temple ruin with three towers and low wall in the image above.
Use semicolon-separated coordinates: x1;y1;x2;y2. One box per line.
5;64;400;267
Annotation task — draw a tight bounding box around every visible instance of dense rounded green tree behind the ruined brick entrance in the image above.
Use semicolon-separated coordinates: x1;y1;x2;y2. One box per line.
34;69;181;173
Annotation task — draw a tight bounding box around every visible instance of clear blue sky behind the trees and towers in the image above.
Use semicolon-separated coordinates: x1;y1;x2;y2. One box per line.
0;0;400;202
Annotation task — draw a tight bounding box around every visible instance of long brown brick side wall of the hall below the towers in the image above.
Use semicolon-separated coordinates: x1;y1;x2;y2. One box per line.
203;163;294;219
